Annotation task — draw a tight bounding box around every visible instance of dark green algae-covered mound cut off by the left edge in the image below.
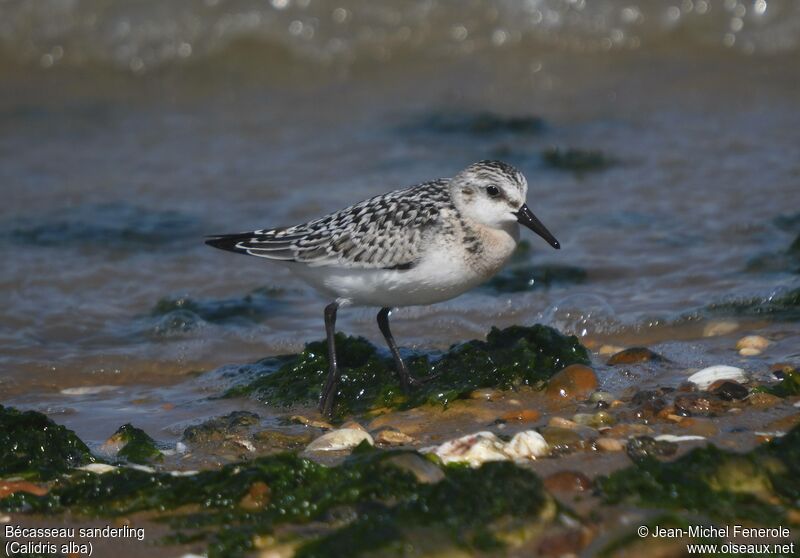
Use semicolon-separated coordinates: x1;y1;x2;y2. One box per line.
0;405;95;480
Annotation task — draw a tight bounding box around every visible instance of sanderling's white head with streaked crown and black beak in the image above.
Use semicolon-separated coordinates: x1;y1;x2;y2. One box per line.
449;161;560;249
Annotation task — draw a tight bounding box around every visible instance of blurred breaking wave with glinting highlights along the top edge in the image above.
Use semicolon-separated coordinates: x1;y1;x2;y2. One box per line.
0;0;800;72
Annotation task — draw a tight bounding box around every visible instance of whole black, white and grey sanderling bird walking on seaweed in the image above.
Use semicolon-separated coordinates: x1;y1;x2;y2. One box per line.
206;161;560;415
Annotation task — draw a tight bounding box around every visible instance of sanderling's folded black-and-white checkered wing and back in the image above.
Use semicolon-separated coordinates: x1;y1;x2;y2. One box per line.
206;179;454;269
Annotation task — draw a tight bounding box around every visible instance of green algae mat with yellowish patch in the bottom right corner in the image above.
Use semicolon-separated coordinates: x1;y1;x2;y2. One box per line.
595;427;800;525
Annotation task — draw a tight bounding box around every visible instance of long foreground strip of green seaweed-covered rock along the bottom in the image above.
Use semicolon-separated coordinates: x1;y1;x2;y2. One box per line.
0;449;556;558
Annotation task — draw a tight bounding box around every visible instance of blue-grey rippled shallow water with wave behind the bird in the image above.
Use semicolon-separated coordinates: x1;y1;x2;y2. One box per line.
0;0;800;441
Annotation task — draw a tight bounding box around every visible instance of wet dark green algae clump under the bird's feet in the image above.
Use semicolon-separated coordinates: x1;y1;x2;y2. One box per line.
227;325;589;416
